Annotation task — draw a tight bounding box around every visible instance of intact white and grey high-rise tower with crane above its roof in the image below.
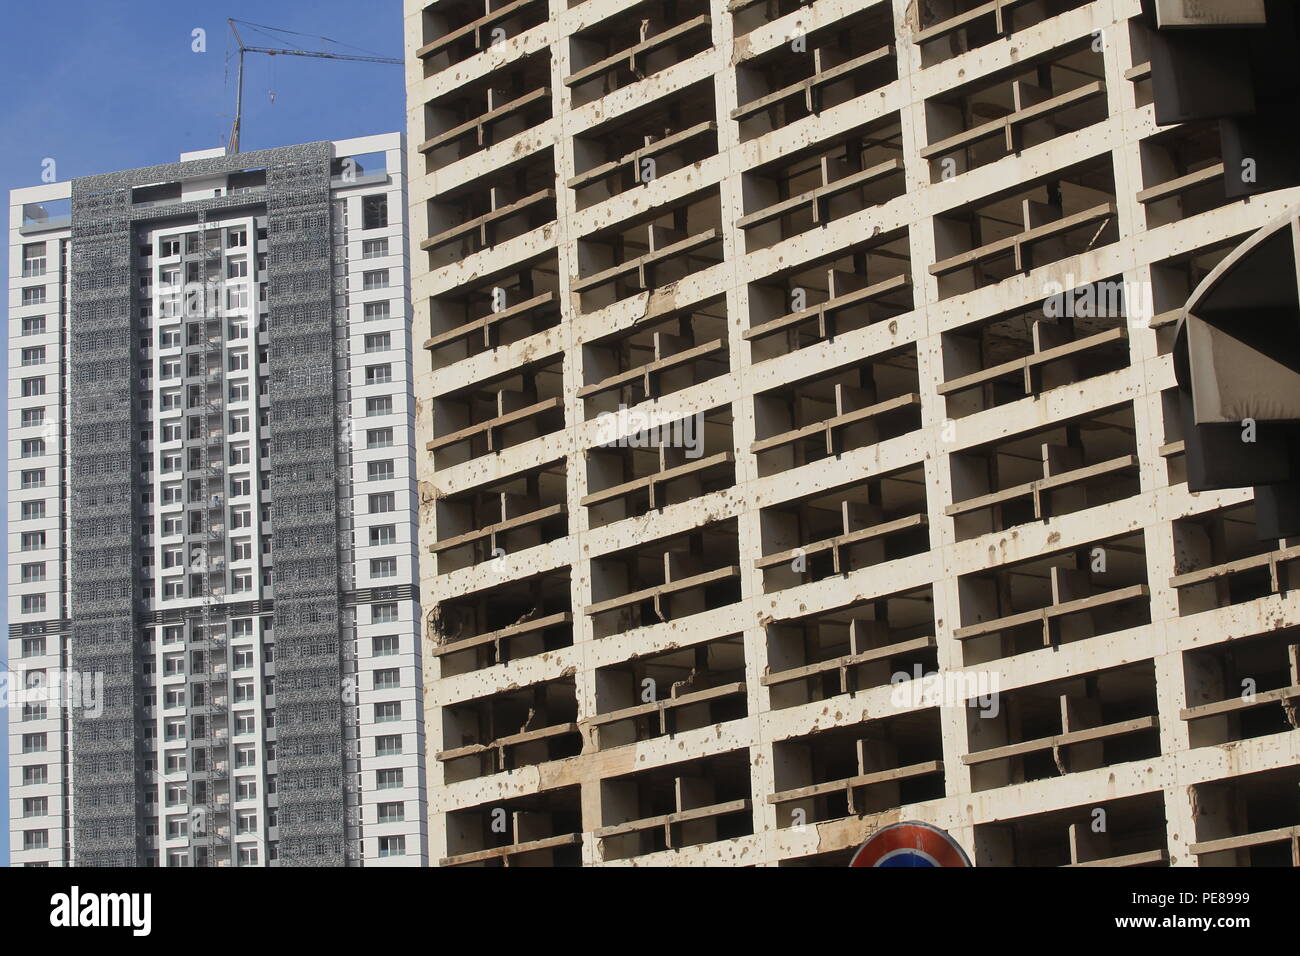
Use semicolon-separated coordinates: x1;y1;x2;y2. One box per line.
8;134;426;866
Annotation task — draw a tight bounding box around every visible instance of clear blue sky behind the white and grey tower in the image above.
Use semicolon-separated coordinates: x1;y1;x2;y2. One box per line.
0;0;406;865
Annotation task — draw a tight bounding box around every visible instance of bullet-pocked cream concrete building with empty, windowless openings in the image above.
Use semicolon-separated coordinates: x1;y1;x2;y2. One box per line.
406;0;1300;866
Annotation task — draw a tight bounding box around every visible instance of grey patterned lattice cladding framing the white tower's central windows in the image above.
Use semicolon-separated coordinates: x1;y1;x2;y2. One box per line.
70;143;348;866
